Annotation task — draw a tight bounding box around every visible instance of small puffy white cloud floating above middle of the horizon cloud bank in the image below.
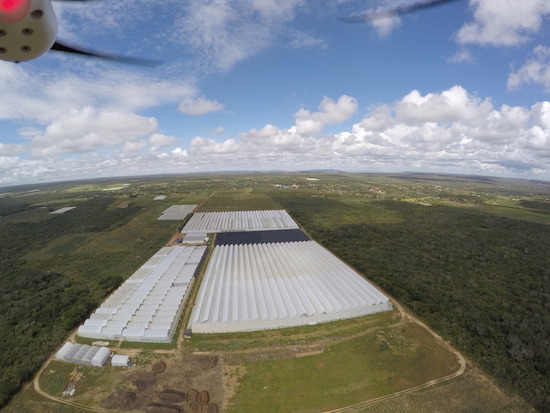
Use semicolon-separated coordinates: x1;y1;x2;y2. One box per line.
294;95;357;135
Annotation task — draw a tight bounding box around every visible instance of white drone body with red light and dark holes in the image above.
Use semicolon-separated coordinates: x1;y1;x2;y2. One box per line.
0;0;57;62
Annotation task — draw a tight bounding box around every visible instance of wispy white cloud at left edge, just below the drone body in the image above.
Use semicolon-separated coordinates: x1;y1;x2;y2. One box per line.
0;62;196;124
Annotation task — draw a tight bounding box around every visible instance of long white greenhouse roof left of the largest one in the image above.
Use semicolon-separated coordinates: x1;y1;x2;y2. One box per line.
78;246;206;342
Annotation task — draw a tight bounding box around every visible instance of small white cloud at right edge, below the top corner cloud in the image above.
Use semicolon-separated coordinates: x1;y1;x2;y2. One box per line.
508;45;550;92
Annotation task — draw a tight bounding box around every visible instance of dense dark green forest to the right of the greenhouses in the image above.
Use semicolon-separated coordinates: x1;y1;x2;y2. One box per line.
274;194;550;412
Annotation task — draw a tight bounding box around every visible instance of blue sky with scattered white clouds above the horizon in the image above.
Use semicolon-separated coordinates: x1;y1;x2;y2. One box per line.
0;0;550;186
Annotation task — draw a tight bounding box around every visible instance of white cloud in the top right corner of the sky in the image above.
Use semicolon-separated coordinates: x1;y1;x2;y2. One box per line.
456;0;550;46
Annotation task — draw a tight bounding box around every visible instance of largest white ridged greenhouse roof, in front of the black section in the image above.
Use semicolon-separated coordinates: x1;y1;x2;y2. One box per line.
190;241;392;333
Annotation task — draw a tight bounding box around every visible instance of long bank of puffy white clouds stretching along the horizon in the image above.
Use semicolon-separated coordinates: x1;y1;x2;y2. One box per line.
0;86;550;184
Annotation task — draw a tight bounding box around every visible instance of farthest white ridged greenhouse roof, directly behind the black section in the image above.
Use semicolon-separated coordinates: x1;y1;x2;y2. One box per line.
181;209;298;233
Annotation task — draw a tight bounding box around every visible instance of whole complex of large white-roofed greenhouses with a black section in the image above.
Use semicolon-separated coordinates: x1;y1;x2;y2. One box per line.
78;209;392;342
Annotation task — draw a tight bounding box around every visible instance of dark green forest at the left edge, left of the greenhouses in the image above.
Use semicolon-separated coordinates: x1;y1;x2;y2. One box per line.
0;197;144;407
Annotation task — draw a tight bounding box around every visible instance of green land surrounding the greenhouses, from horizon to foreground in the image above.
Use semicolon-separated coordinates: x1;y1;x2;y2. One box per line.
0;173;550;412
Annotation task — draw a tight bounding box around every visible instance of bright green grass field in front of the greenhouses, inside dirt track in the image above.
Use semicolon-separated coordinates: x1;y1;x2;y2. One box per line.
228;324;458;412
